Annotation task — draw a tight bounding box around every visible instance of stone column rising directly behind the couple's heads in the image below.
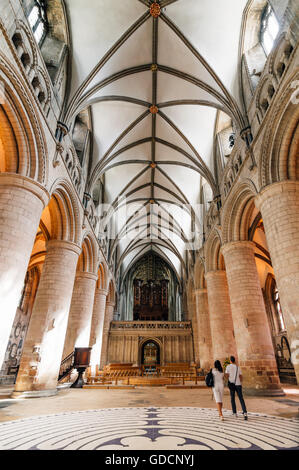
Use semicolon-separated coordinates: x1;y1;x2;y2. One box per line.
205;270;237;364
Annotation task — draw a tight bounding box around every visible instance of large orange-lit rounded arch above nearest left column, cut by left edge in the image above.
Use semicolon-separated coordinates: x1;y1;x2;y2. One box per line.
0;53;48;184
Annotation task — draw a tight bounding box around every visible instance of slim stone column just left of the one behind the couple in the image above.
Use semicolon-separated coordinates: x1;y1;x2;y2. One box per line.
195;289;213;370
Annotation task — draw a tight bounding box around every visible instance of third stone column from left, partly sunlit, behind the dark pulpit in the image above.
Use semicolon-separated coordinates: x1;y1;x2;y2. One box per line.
62;272;98;359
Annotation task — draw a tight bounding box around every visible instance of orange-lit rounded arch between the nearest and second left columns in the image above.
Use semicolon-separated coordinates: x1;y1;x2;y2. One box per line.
48;179;82;245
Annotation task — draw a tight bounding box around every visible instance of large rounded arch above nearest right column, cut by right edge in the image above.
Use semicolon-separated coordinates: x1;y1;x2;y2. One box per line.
259;72;299;189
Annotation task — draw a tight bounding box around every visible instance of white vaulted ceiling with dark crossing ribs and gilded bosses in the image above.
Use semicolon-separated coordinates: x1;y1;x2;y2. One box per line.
65;0;247;280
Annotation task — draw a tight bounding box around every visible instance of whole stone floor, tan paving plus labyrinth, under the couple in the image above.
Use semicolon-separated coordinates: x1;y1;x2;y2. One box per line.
0;386;299;450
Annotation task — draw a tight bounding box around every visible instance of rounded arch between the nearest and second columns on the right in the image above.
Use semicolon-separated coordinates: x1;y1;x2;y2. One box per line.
222;180;257;244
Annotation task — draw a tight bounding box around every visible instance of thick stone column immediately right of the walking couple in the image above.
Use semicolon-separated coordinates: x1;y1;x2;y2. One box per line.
221;241;282;395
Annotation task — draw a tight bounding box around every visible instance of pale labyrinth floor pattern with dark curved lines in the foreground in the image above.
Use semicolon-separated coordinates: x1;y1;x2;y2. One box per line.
0;407;299;450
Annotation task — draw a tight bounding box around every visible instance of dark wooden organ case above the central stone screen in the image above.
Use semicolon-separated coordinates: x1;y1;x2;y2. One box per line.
133;279;169;321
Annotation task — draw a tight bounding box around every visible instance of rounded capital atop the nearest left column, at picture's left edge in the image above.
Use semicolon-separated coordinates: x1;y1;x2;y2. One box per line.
0;173;50;208
